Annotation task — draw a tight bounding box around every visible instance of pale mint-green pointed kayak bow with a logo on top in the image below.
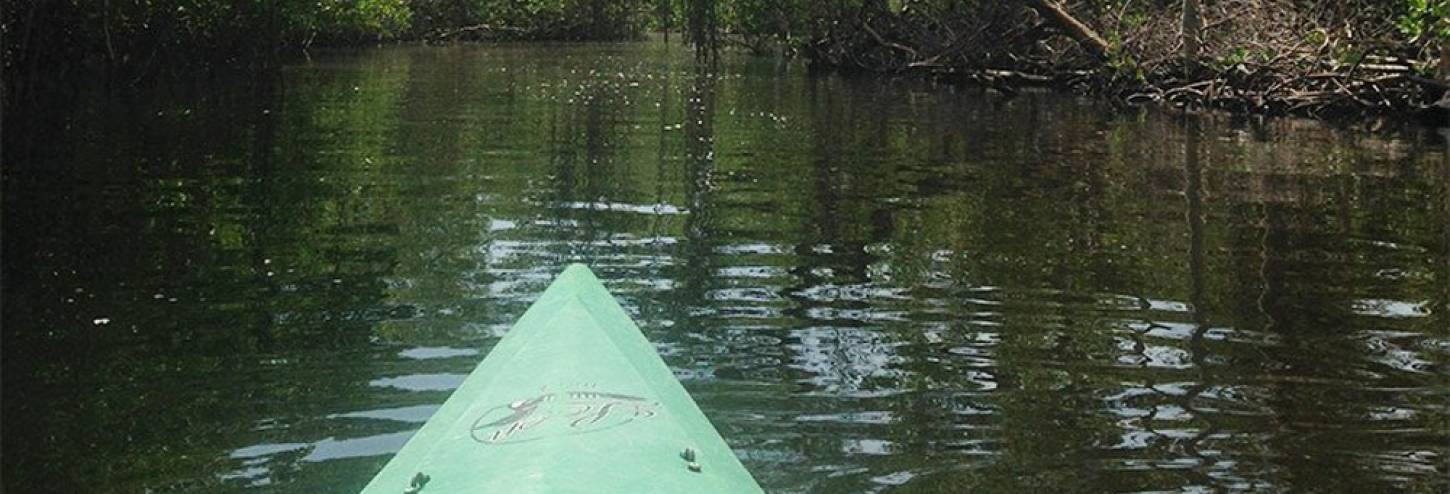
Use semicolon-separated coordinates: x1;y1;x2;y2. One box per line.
363;264;761;494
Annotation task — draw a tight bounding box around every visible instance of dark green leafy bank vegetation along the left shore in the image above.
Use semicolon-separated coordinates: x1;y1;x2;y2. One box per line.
0;0;652;80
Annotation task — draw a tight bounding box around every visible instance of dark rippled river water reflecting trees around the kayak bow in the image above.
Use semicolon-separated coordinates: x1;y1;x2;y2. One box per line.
0;43;1450;493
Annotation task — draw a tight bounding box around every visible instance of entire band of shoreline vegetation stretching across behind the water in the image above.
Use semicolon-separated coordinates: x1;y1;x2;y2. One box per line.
0;0;1450;125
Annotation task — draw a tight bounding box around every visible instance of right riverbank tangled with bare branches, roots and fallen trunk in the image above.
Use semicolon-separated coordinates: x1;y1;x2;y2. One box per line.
805;1;1450;126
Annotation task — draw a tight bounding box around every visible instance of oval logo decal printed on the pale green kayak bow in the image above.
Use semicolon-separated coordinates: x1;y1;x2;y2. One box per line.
470;390;660;445
